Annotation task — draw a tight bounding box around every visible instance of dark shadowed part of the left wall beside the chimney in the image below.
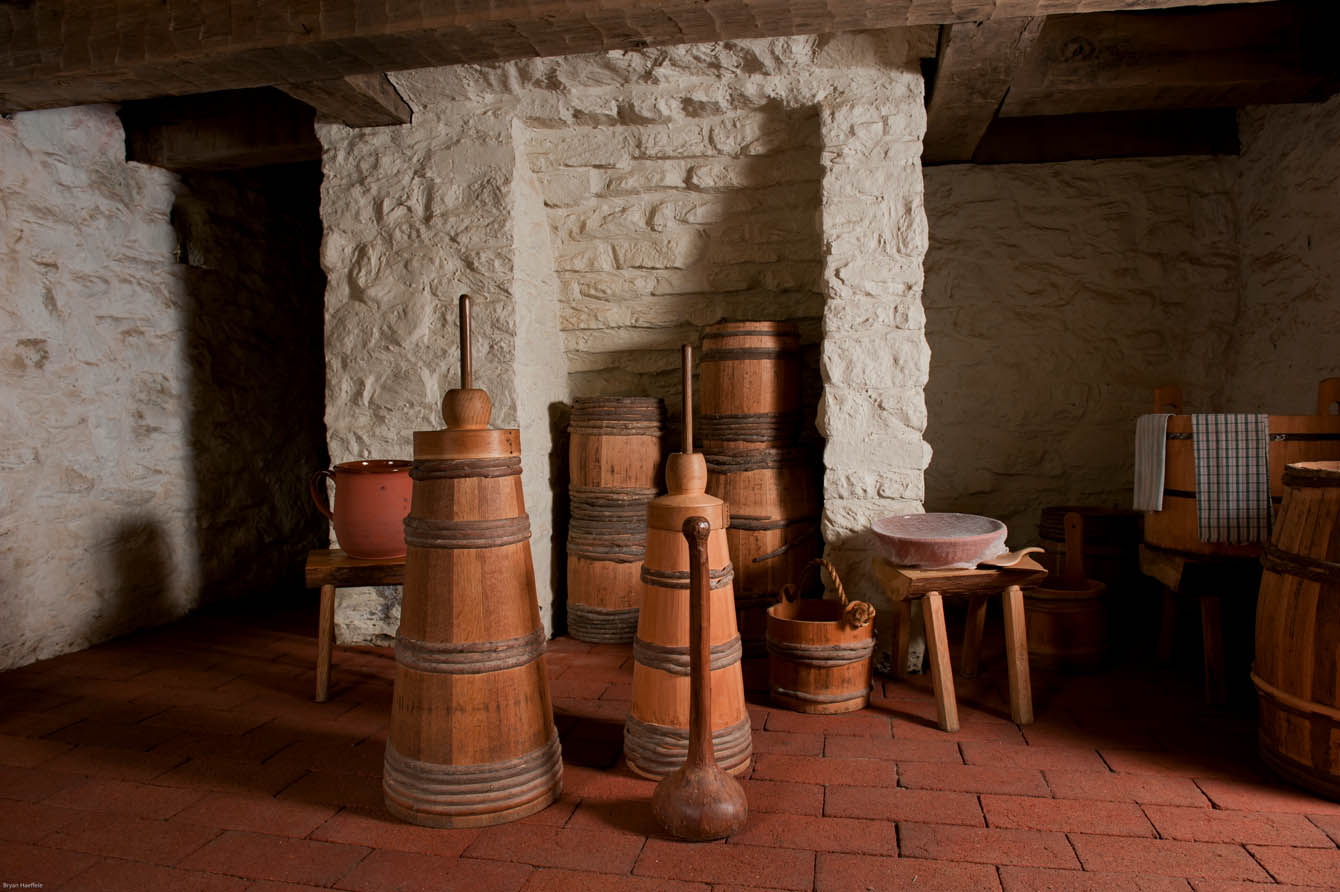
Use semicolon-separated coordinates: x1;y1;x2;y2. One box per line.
173;162;330;603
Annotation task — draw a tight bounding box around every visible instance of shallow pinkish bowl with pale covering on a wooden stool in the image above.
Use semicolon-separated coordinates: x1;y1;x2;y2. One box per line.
870;513;1009;569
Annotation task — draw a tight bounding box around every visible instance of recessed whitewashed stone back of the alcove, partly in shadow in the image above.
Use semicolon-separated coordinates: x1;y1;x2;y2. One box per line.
537;104;824;618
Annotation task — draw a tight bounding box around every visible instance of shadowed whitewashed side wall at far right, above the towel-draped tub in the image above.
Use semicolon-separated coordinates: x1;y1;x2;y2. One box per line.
1223;96;1340;415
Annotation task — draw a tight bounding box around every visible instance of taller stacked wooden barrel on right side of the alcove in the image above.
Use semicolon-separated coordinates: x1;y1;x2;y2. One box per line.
698;321;823;656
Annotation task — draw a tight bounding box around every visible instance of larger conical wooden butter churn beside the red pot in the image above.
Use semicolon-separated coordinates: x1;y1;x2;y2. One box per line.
382;296;563;828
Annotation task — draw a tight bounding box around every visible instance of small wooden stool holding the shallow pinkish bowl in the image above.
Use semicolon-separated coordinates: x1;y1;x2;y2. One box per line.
875;557;1047;731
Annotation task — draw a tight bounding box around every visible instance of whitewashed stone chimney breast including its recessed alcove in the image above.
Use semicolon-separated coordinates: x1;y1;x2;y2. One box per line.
320;31;927;640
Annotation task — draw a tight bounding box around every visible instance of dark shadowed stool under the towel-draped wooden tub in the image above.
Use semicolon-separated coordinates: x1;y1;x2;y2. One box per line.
1140;545;1261;704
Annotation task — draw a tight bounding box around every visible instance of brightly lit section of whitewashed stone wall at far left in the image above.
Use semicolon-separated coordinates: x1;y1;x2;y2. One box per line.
0;106;197;668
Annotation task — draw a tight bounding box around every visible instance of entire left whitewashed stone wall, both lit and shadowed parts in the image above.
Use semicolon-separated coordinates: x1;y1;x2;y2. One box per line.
0;106;326;668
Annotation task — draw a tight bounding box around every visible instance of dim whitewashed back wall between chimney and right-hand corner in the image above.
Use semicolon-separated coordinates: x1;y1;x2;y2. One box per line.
926;158;1232;545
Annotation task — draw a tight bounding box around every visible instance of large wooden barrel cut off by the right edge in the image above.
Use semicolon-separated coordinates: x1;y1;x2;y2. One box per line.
1252;461;1340;800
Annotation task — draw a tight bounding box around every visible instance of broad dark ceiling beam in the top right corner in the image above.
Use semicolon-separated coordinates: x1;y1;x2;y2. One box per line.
1000;3;1340;118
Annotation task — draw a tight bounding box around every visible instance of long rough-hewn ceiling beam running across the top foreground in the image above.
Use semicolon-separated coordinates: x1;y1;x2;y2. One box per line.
0;0;1265;111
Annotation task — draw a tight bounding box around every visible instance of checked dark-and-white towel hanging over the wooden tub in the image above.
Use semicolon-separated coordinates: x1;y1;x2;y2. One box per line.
1191;414;1272;542
